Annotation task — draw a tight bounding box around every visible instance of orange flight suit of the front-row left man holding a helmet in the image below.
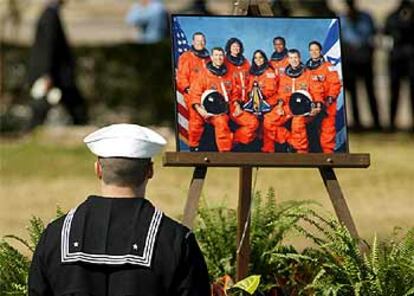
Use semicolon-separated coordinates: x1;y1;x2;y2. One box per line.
188;65;238;152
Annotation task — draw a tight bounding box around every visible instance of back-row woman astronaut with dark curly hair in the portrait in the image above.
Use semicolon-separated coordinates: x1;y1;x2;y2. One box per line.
224;38;259;151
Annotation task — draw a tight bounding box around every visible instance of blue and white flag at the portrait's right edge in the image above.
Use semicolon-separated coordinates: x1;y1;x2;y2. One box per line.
323;19;347;152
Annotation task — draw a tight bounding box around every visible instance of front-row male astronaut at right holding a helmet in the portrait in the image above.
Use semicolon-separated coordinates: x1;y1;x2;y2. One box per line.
278;49;324;153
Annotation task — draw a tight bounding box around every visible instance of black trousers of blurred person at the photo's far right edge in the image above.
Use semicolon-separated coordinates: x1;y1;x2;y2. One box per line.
388;48;414;129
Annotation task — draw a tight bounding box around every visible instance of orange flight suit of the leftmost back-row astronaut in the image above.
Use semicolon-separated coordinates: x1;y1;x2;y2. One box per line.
176;50;210;109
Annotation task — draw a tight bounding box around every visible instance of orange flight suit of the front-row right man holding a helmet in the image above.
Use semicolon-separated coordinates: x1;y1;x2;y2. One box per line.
272;69;323;153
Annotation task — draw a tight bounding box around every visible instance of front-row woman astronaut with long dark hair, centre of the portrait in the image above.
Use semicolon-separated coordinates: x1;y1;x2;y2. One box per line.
247;50;288;152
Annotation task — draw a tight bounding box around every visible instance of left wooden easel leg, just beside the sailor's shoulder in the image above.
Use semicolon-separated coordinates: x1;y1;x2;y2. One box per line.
183;167;207;229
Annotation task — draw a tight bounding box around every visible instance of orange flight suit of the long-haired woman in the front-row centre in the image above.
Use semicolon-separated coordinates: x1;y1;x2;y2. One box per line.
247;67;289;152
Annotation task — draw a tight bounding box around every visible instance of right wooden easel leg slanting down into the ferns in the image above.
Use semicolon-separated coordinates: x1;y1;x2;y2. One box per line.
319;167;359;238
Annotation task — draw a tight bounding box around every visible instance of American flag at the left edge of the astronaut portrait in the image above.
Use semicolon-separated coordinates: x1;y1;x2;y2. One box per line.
172;17;190;151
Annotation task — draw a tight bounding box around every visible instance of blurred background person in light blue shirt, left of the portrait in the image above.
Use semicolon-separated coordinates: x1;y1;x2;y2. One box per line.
125;0;168;43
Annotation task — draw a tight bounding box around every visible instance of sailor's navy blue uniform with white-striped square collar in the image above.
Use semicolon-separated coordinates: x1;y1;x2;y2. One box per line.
29;196;210;296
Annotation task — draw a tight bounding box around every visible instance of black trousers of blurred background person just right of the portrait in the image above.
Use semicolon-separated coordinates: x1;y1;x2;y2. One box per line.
344;58;381;128
